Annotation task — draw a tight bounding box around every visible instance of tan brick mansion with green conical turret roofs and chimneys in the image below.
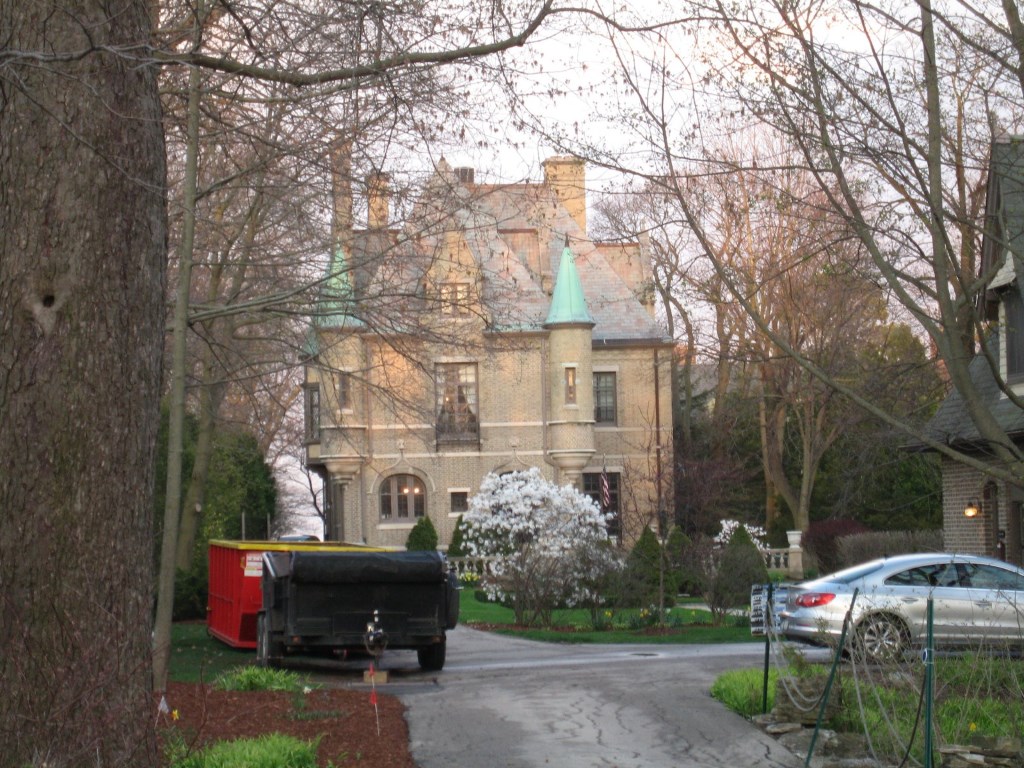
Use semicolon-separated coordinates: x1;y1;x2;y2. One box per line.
305;158;673;547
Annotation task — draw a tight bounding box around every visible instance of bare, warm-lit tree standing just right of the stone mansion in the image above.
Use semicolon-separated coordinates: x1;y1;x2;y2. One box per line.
593;131;885;529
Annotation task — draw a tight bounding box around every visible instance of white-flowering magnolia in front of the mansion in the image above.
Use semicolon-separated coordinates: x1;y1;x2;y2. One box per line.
463;467;621;626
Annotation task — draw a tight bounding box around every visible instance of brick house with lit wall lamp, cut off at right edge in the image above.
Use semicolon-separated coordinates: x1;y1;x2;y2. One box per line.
927;136;1024;564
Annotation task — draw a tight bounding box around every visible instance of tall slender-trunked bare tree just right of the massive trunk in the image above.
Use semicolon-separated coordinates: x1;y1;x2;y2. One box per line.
148;2;565;687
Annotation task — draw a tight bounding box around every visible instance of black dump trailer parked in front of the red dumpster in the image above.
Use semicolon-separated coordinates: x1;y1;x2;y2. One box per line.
256;552;459;670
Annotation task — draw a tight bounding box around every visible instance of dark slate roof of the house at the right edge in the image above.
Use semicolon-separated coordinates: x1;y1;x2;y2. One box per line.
918;136;1024;447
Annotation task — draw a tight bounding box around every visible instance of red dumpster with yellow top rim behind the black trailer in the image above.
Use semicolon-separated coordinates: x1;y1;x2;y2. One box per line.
206;539;386;648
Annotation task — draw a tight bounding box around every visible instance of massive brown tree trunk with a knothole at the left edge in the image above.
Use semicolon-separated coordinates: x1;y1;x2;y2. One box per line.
0;0;166;766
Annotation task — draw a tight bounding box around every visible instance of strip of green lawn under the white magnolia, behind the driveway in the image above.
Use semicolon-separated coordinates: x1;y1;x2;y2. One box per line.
459;589;754;644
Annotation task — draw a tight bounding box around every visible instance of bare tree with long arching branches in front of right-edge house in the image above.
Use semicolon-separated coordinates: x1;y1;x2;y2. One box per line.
516;0;1024;493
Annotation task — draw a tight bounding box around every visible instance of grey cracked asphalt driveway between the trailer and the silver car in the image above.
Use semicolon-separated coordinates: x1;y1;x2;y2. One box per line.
372;627;803;768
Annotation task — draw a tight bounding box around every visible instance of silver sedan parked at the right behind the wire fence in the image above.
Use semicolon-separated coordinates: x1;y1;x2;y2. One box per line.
780;553;1024;660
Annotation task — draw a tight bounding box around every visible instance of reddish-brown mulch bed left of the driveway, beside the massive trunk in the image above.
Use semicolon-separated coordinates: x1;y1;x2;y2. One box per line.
161;683;416;768
